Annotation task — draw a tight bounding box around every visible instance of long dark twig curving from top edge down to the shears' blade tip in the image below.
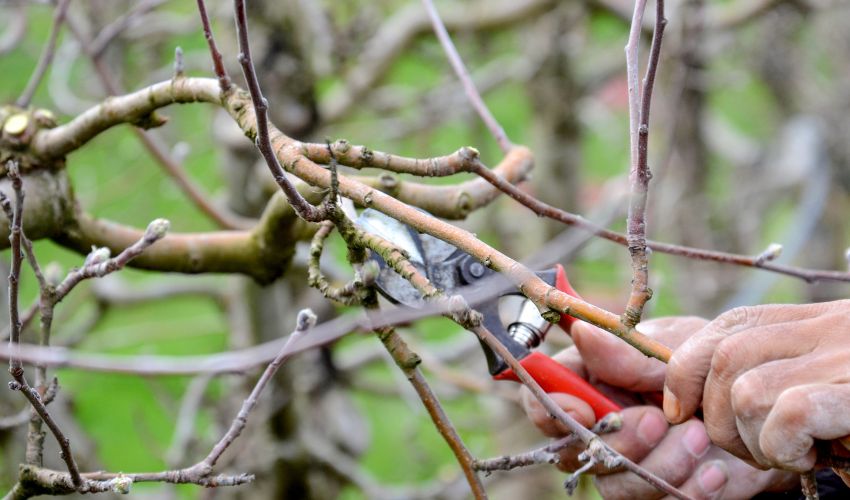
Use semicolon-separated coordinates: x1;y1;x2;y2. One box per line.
234;0;327;222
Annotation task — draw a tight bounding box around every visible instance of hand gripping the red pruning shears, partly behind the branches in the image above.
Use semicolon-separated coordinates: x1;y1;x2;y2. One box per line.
522;317;797;499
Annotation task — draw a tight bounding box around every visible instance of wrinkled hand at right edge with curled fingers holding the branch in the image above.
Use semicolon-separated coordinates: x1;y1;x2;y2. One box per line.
664;300;850;484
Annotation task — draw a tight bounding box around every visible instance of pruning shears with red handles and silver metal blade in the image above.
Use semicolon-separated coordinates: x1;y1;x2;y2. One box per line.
357;209;621;420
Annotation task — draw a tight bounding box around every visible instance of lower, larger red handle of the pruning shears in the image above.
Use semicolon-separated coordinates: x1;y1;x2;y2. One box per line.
493;352;620;420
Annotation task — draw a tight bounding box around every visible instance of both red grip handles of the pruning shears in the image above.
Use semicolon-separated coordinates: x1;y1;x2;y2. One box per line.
486;264;621;420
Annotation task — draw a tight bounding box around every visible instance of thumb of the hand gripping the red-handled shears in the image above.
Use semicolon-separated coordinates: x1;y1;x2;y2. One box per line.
572;322;666;392
